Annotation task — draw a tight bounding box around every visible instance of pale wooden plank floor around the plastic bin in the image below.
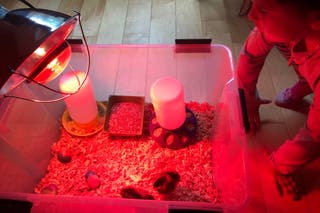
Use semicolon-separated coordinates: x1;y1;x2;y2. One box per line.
0;0;320;212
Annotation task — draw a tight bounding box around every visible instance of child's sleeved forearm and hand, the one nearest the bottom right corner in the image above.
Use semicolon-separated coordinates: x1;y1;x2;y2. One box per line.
270;128;320;200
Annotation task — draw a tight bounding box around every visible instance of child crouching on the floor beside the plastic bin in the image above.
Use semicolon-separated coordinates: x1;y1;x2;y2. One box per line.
237;0;320;199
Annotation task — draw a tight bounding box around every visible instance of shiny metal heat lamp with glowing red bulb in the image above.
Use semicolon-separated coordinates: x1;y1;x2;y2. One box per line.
0;8;83;101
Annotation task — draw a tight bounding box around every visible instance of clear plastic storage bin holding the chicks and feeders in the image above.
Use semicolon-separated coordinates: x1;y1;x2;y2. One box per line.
0;44;249;212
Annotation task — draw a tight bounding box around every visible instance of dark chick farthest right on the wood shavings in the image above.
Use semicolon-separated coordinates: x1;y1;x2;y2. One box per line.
153;171;180;194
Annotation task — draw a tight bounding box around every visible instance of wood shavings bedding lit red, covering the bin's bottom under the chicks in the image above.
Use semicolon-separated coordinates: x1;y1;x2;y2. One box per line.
34;102;242;204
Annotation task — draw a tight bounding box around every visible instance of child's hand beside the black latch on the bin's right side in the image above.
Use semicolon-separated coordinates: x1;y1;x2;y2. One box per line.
245;92;271;134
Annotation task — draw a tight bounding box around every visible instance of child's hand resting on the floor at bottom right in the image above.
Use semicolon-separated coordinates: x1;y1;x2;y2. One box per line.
273;171;302;200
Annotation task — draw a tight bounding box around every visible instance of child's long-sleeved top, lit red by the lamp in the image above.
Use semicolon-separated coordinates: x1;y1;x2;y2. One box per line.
236;28;320;174
